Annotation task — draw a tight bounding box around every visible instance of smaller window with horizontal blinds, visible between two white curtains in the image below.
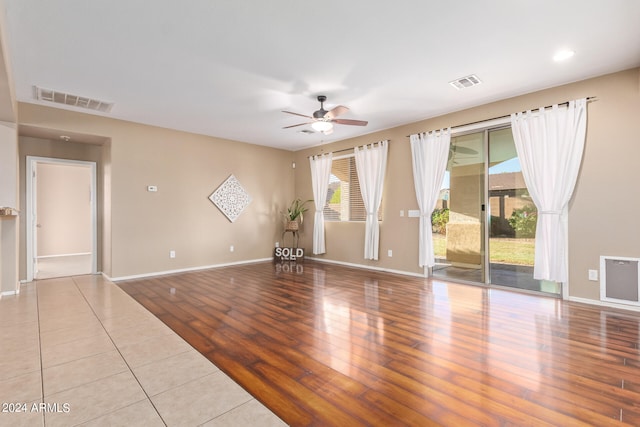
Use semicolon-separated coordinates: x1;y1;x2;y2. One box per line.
324;156;382;221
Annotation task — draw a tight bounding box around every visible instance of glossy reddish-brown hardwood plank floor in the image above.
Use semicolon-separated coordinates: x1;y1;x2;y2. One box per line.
119;261;640;426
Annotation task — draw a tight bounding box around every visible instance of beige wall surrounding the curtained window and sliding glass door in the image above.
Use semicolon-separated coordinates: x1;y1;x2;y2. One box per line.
296;69;640;299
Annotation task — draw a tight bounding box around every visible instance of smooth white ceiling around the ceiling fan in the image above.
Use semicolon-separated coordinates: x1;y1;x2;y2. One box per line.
0;0;640;150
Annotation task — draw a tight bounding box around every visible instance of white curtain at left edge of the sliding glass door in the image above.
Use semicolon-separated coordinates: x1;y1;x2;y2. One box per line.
410;128;451;267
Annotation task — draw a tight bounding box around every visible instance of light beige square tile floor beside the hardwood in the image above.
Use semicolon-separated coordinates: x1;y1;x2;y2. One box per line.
0;276;285;427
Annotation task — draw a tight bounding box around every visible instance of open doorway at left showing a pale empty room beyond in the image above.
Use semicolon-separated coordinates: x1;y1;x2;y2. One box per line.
26;156;97;281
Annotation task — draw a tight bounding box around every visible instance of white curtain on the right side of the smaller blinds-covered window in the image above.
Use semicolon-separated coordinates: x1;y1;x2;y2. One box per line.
353;140;389;259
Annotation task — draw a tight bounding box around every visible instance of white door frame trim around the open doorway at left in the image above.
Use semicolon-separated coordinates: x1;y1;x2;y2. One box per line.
25;156;98;282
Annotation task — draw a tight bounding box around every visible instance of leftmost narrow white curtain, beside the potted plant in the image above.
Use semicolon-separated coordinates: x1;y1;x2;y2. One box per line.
309;153;333;255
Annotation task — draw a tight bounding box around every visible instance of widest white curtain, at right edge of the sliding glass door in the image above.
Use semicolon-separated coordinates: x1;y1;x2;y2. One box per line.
511;99;587;282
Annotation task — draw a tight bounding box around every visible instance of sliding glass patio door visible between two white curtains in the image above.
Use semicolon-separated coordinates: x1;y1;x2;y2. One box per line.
432;127;561;294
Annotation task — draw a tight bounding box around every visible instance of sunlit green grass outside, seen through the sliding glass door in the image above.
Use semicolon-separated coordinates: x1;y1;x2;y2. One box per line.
433;234;535;266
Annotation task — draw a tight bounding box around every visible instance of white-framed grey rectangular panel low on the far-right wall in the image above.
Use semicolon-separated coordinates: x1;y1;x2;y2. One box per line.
600;256;640;305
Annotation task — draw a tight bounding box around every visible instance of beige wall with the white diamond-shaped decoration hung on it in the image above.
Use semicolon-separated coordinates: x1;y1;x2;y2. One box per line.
19;104;294;278
